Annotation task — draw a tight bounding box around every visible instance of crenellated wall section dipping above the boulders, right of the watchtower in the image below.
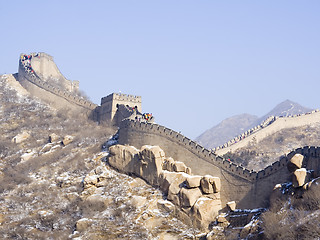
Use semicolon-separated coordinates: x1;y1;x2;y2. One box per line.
119;120;320;208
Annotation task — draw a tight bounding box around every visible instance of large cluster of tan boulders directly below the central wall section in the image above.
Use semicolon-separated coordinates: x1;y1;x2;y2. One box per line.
107;145;222;229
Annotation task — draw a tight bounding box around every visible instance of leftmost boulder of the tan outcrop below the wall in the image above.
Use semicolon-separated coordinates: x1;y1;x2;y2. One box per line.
109;144;140;176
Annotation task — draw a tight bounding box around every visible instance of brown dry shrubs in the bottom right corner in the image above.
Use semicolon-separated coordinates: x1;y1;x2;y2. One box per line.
262;185;320;240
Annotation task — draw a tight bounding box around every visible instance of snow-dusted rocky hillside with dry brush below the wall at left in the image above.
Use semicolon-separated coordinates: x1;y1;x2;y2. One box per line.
0;75;197;239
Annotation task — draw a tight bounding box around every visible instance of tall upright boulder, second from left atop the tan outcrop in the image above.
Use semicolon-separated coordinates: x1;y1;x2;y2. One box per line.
140;145;165;185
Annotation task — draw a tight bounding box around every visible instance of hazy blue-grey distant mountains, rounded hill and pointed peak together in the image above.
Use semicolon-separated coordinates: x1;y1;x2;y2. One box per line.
195;100;312;148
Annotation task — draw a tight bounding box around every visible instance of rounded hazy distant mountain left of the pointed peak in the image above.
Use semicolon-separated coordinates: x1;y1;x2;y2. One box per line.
196;113;259;148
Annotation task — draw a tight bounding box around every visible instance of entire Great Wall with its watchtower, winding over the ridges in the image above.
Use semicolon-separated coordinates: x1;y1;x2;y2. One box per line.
10;53;320;208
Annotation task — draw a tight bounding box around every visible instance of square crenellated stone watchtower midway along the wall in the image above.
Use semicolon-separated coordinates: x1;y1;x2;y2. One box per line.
100;93;142;124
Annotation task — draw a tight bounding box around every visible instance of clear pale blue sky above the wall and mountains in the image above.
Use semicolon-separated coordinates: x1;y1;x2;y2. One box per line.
0;0;320;138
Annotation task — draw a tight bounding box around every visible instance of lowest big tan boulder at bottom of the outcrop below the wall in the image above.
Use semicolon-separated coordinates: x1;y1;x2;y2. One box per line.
192;197;221;229
